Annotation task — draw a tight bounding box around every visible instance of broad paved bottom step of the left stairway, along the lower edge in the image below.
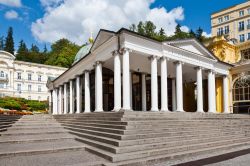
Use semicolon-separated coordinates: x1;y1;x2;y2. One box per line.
0;149;108;166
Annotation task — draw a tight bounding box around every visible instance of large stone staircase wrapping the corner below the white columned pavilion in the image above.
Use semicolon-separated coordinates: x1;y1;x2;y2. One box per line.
54;111;250;165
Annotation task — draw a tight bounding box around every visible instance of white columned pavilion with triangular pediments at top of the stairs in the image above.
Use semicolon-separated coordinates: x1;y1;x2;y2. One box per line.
48;28;232;114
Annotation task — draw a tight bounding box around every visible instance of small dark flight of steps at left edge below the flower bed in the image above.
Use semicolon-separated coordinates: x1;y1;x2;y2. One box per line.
0;115;21;132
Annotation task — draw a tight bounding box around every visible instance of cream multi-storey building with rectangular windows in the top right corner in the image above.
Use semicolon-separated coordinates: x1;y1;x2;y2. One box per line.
211;1;250;43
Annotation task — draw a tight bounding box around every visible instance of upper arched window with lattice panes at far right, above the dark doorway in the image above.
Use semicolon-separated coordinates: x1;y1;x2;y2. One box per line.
233;75;250;102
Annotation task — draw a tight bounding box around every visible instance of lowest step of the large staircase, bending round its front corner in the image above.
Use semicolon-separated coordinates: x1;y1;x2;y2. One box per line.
86;138;250;162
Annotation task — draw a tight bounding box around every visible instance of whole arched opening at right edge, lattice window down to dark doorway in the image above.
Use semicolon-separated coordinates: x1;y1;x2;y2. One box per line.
232;73;250;113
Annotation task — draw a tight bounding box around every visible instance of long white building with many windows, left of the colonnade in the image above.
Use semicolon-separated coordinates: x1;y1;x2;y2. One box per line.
0;51;66;100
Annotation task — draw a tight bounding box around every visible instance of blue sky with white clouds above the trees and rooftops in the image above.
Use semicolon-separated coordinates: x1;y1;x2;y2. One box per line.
0;0;245;49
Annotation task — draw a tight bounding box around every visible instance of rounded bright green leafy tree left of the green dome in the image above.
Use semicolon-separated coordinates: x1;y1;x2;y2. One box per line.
45;39;80;67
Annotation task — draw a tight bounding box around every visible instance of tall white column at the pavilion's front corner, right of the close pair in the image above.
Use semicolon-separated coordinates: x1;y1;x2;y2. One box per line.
122;48;131;111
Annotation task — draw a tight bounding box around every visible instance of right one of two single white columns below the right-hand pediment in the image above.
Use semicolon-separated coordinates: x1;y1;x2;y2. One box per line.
196;67;204;112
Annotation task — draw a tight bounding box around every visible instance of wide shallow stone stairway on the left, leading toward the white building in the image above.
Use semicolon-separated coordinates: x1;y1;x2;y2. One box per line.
0;115;106;166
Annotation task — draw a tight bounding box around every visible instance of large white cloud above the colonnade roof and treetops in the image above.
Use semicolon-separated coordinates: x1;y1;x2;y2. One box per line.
31;0;187;44
